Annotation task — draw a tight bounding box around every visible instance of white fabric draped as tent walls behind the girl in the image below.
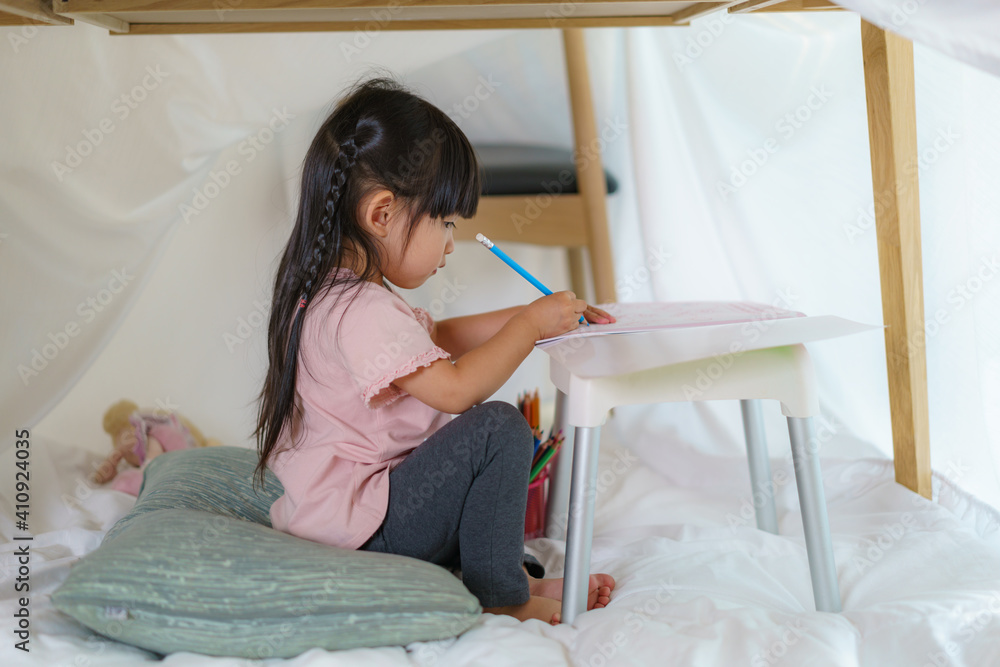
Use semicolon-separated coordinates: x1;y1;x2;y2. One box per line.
0;0;1000;665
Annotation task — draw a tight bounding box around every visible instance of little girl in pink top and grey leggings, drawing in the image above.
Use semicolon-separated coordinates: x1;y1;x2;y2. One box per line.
255;79;614;623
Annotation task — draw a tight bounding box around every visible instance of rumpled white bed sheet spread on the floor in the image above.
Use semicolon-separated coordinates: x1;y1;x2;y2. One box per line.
0;412;1000;667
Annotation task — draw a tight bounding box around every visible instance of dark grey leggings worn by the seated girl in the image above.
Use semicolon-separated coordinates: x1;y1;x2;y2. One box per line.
360;401;545;607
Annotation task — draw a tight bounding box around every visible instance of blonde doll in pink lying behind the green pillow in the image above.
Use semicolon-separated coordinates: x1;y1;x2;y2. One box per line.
91;400;219;496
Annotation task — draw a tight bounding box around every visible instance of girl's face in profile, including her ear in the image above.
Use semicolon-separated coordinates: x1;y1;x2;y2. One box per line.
362;190;457;289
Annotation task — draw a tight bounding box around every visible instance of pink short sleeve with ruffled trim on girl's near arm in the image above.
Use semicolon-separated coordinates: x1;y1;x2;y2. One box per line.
339;290;451;410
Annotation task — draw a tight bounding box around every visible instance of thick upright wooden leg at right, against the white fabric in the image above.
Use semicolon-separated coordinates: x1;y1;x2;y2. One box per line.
861;20;931;498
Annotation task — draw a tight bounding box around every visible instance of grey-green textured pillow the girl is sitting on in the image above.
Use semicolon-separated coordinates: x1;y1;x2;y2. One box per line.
52;447;482;658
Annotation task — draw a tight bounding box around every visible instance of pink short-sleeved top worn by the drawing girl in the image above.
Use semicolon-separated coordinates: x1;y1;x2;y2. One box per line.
269;269;452;549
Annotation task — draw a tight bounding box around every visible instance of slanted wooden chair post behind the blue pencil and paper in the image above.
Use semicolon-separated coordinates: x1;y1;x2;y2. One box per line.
562;28;617;303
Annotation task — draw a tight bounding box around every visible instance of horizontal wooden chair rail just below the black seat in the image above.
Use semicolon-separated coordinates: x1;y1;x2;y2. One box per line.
454;194;587;247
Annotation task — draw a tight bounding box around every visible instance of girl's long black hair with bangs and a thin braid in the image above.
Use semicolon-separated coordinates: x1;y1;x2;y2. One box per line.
254;77;480;485
